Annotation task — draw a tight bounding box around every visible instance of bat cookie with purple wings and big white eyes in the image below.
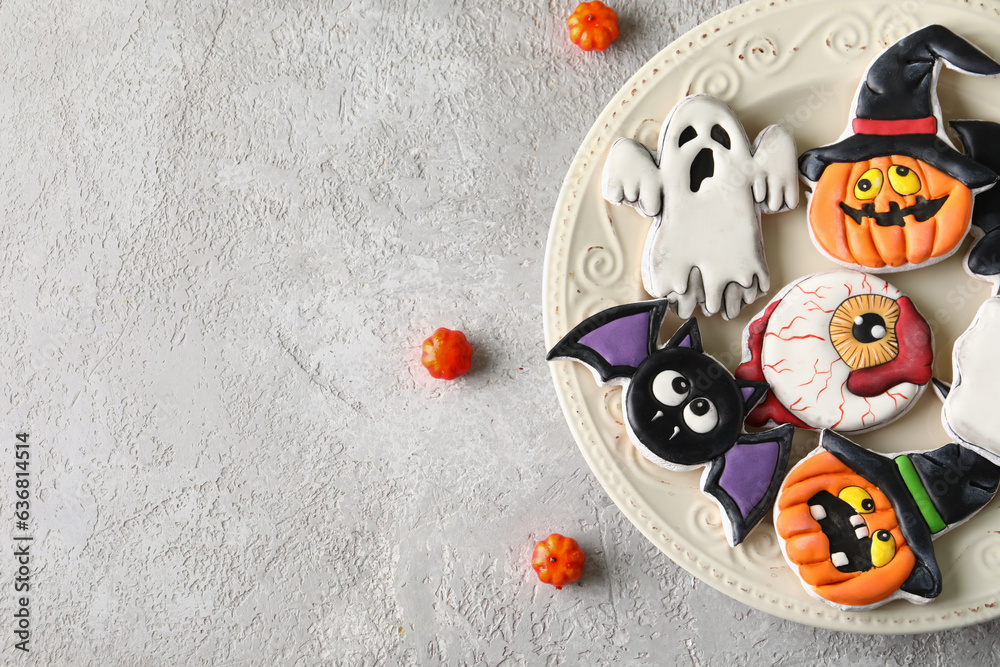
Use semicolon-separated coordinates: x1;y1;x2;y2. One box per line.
547;299;794;546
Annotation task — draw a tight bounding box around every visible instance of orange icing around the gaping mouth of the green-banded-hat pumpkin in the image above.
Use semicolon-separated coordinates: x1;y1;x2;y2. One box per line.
775;452;917;607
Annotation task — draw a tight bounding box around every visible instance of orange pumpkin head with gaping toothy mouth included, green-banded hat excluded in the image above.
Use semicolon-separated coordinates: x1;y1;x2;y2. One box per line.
776;452;917;606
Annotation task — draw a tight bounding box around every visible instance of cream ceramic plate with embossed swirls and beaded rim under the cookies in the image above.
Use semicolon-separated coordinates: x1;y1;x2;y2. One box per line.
544;0;1000;633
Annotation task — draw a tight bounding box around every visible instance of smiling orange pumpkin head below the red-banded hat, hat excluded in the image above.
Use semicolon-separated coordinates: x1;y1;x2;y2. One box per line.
809;155;972;269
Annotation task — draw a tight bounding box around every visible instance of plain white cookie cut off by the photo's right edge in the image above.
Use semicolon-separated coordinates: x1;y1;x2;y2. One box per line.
938;296;1000;463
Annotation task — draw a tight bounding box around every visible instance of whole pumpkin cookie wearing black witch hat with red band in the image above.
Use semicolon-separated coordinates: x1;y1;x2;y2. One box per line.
799;25;1000;272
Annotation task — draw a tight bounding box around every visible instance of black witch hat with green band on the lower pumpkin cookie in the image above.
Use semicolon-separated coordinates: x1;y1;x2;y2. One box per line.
820;431;1000;599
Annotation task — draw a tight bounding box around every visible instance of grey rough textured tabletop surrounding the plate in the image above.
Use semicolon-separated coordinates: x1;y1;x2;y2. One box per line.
0;0;1000;665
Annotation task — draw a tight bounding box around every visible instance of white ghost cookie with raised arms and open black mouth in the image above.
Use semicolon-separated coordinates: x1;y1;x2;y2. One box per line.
603;95;798;319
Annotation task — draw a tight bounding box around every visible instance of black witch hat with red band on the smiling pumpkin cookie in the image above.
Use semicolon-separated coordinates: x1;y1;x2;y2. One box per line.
799;25;1000;190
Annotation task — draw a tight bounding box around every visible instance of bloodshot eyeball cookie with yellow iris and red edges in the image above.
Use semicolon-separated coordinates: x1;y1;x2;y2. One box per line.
736;271;934;433
